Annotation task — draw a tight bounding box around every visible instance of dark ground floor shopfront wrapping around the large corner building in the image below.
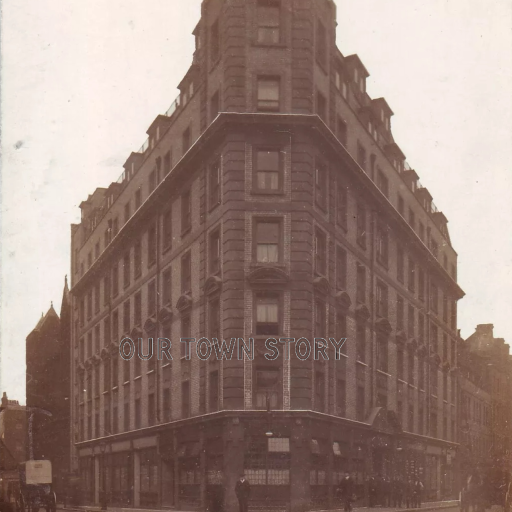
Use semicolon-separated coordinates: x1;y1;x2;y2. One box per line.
77;409;453;512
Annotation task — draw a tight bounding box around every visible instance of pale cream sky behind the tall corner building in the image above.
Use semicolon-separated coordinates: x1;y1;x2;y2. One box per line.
0;0;512;403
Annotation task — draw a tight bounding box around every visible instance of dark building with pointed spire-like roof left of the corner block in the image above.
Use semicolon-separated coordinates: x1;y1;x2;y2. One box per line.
26;278;70;496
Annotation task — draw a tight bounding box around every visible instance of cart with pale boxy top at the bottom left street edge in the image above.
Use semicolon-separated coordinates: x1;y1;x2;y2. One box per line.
17;460;57;512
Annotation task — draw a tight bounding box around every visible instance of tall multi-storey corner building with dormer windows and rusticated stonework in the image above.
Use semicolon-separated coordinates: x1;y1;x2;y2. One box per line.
72;0;463;511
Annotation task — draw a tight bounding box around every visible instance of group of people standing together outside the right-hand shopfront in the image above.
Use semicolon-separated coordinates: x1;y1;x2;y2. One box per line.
368;475;424;508
